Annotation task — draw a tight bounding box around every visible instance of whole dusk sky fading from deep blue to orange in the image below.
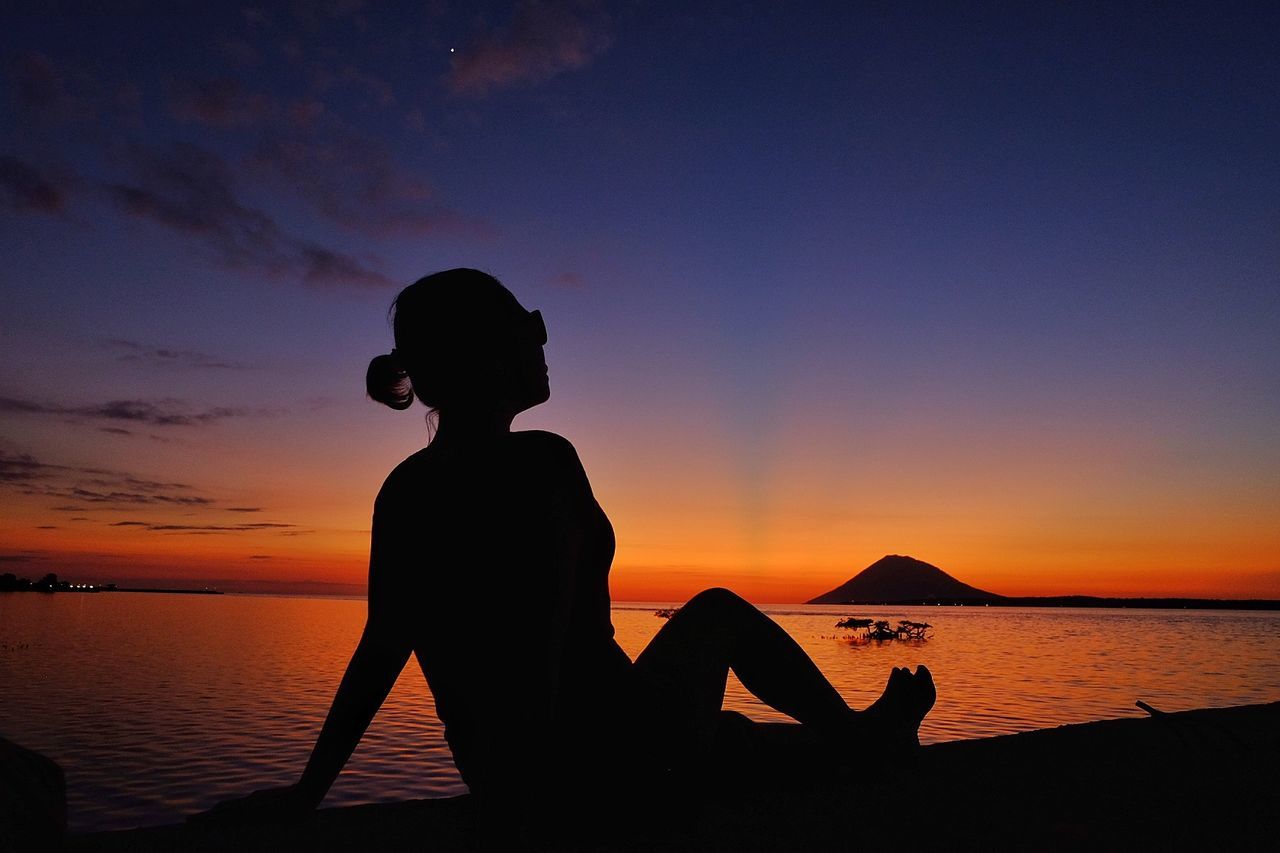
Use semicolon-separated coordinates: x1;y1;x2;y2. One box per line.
0;0;1280;602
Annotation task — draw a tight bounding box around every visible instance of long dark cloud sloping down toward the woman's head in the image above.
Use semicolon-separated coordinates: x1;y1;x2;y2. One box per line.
101;142;394;288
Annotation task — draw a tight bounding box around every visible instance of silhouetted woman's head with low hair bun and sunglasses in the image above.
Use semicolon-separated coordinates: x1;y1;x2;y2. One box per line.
365;268;550;415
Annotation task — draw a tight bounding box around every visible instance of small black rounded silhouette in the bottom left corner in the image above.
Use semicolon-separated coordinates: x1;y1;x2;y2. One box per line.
0;738;67;850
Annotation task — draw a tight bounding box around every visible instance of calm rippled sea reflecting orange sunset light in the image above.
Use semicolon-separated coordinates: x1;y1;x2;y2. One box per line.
0;593;1280;830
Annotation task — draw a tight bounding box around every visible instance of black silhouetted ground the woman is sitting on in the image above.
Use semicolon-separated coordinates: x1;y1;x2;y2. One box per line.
65;702;1280;853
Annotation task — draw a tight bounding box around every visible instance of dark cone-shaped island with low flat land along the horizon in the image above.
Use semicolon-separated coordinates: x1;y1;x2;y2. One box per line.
805;553;1280;610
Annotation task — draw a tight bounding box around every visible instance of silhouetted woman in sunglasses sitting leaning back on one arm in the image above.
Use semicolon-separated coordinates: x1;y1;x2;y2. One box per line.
207;269;934;835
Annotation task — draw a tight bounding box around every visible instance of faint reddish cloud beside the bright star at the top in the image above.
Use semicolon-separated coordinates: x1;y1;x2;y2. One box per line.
445;0;611;96
